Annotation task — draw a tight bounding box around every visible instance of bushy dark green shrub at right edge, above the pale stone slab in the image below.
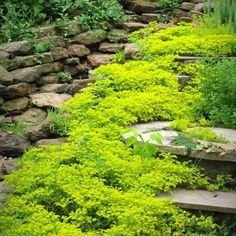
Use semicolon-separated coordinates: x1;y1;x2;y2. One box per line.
195;60;236;128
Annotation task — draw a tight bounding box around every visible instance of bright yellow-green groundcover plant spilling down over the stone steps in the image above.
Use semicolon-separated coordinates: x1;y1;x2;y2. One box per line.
0;23;235;236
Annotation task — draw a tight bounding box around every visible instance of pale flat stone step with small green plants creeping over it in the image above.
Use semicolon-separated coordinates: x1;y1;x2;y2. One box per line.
123;121;236;163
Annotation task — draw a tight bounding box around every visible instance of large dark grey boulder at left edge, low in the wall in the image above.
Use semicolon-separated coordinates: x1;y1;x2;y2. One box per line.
0;131;30;157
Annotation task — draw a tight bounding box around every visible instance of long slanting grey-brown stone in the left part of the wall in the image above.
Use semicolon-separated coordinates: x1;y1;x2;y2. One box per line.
10;62;60;83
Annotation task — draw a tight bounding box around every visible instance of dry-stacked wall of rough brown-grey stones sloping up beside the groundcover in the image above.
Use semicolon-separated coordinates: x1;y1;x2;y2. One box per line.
0;0;205;159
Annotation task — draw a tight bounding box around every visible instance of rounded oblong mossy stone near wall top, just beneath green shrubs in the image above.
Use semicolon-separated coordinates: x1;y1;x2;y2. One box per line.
72;29;106;45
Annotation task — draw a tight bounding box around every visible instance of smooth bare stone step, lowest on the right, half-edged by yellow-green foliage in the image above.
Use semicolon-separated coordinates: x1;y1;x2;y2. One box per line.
158;189;236;214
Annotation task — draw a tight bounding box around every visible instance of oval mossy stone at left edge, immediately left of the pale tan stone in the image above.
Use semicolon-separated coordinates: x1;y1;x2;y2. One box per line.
2;97;30;114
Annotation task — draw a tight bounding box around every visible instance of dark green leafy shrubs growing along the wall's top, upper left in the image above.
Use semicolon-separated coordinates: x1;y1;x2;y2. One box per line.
0;0;123;42
